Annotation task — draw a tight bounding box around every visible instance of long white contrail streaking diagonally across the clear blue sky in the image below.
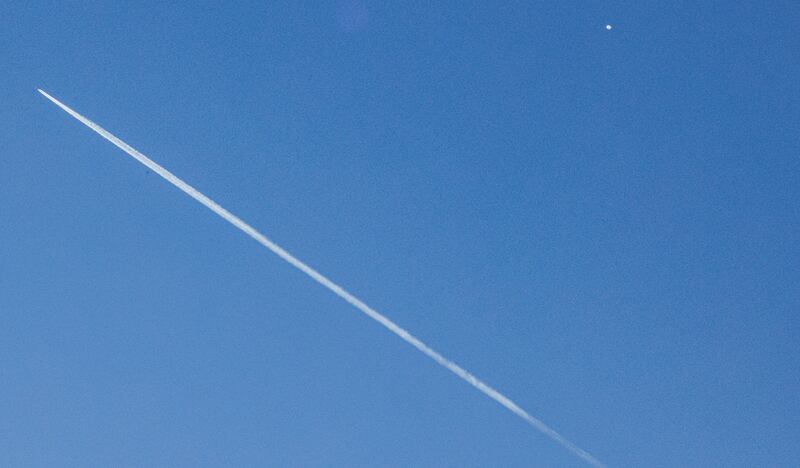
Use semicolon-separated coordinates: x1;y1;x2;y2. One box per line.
37;88;605;467
